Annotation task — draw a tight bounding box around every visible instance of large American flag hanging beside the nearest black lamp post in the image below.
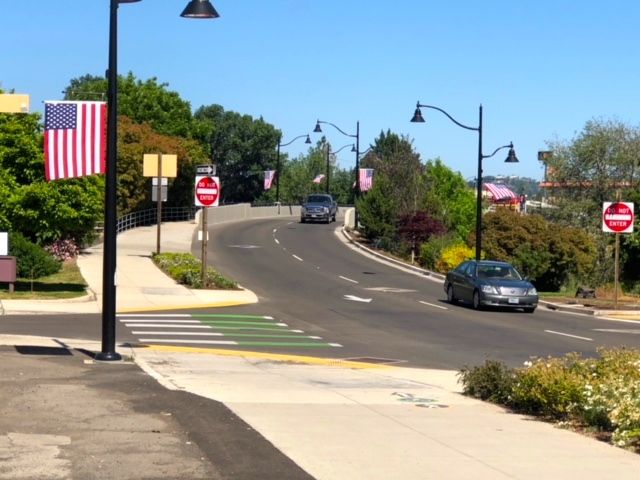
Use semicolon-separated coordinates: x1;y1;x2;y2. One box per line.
44;102;107;181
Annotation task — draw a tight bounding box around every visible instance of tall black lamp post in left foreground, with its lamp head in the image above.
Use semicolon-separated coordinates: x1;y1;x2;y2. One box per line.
95;0;219;361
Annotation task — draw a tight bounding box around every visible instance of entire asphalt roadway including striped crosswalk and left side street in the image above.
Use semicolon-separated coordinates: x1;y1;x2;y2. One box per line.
2;220;640;369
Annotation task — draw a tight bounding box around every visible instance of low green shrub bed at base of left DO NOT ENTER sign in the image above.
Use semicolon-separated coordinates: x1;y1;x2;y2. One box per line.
152;253;238;290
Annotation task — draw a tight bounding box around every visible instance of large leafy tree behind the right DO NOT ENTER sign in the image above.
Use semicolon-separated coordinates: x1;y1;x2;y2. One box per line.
543;120;640;285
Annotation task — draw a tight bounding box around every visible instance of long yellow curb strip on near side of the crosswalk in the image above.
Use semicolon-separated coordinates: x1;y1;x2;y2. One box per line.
136;344;393;370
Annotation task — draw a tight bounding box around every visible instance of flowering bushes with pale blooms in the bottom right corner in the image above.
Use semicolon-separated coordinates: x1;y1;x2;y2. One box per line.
459;349;640;453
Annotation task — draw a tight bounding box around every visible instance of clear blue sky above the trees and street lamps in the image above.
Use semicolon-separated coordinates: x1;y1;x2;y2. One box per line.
5;0;640;179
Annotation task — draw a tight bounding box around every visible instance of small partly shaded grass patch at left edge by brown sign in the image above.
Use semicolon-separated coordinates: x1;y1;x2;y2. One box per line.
0;260;87;300
